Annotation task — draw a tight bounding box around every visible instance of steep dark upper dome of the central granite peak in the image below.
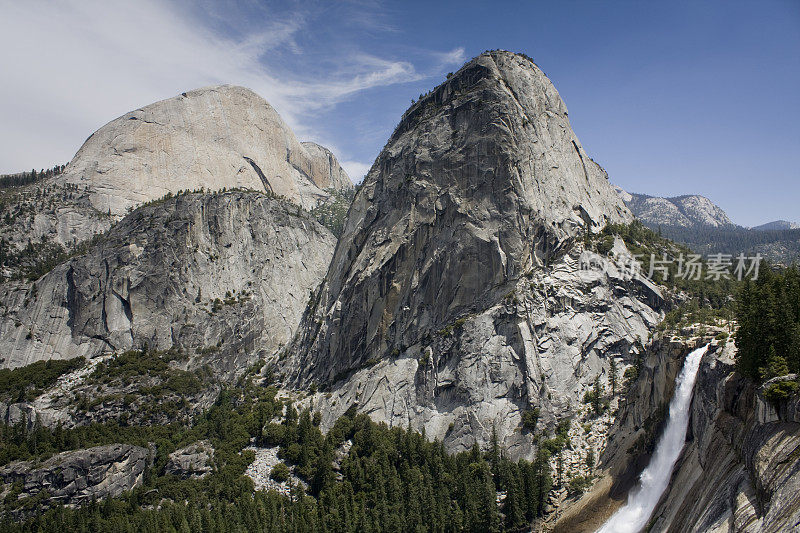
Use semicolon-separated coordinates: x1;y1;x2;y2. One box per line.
291;51;632;390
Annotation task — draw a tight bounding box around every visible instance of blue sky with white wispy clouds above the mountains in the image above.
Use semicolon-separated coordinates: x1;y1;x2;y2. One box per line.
0;0;800;225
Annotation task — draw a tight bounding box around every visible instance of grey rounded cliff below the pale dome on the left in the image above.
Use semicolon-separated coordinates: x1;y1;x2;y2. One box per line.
0;191;335;377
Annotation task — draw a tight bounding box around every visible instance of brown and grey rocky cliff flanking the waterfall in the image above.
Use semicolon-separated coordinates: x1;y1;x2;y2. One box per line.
554;326;800;533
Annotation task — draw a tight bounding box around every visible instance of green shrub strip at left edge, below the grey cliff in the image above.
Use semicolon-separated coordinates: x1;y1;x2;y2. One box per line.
0;357;86;403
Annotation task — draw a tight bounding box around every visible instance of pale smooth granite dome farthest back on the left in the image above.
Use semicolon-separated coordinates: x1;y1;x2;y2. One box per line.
0;85;353;262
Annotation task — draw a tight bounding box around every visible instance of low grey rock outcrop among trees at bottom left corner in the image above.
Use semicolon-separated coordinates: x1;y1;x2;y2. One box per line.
0;444;149;506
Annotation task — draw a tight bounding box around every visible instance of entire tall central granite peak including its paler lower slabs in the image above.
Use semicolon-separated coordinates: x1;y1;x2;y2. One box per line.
284;51;660;455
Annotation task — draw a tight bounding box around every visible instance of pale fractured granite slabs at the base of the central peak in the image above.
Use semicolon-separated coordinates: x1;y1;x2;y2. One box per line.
304;245;661;457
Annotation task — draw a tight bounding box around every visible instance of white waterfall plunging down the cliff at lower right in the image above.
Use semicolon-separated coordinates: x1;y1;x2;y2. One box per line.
597;346;708;533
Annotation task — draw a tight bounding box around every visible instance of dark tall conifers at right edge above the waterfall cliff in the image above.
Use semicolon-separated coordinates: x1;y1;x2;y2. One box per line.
736;266;800;388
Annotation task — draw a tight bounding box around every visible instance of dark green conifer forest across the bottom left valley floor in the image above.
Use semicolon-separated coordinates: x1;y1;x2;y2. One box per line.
0;366;569;533
